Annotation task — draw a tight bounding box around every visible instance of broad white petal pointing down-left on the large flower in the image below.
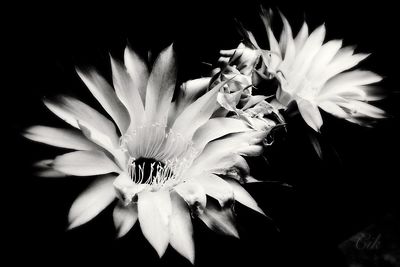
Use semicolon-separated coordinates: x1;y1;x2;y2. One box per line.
68;176;115;229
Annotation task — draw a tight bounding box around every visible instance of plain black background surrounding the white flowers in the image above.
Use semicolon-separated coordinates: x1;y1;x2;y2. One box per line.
7;1;400;266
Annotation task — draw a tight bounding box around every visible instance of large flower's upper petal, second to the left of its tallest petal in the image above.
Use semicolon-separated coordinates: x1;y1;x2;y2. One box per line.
111;57;144;127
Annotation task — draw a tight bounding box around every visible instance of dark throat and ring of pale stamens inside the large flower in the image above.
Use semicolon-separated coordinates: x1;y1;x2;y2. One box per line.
121;124;197;191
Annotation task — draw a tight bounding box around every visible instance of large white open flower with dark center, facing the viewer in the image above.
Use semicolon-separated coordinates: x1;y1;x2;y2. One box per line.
25;45;265;263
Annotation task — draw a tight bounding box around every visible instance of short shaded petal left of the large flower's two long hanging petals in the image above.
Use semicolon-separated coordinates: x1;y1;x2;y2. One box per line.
113;202;138;238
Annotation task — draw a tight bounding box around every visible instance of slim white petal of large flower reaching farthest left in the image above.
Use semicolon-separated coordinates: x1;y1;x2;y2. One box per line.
24;125;98;150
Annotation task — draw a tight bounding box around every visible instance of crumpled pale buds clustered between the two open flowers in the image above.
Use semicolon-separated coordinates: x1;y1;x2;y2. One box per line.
200;43;284;136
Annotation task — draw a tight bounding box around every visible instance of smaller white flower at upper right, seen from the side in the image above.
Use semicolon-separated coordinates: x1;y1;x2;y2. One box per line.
245;9;385;131
